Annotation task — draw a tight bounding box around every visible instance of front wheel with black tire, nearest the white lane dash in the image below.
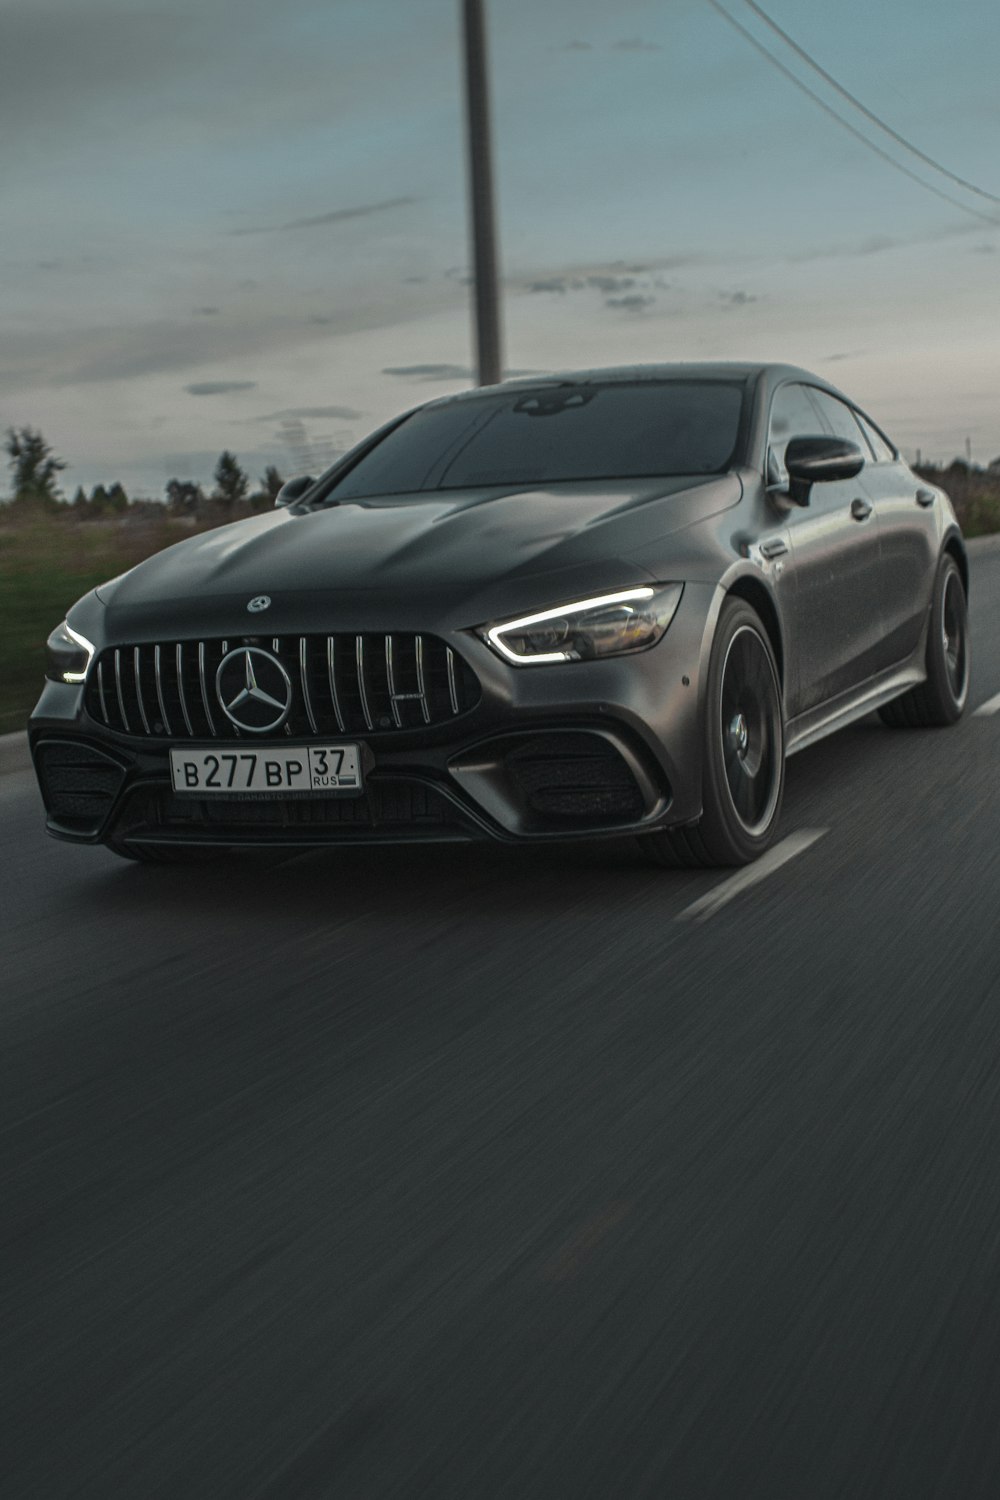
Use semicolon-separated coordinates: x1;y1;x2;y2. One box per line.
640;597;784;867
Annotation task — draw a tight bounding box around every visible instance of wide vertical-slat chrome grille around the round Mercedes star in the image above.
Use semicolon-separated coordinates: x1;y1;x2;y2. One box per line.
85;632;480;740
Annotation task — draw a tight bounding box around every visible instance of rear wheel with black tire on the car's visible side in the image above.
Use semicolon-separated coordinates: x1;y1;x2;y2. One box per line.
879;552;970;729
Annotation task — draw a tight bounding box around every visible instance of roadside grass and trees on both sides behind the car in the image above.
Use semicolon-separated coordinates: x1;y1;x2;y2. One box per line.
0;428;1000;734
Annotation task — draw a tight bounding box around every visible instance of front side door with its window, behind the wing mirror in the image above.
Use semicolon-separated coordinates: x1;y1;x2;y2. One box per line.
768;381;886;717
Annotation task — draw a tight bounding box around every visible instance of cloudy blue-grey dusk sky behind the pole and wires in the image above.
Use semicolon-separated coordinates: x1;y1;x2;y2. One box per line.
0;0;1000;497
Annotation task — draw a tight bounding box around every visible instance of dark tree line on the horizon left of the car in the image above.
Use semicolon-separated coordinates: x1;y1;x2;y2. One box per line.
3;428;283;522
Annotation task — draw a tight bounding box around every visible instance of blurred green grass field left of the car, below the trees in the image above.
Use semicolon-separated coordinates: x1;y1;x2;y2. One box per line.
0;516;206;735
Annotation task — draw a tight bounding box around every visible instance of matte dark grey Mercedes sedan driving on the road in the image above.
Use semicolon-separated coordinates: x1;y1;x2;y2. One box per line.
30;365;969;864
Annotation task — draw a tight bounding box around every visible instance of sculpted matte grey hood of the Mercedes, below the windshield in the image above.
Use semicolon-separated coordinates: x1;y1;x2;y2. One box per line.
99;474;742;639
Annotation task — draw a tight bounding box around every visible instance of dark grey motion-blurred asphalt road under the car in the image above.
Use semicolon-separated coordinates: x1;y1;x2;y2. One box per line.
0;551;1000;1500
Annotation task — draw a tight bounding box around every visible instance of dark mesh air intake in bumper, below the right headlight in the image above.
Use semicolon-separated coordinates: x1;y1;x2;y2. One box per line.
504;732;643;822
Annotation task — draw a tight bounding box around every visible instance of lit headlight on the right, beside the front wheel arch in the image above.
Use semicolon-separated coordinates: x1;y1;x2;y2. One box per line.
480;584;684;666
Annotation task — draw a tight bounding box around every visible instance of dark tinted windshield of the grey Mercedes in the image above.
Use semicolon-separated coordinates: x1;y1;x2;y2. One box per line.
325;380;742;501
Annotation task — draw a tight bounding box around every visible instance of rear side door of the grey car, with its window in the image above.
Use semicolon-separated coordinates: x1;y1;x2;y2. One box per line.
853;411;939;665
